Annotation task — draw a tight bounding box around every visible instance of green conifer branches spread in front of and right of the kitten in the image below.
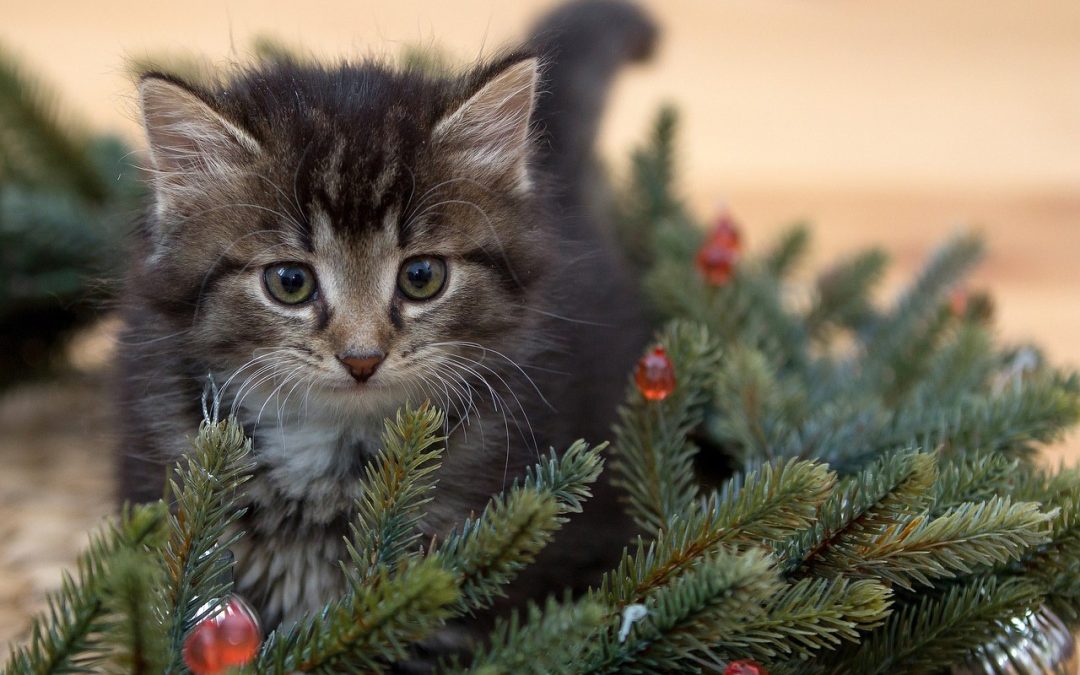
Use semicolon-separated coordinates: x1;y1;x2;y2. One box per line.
5;105;1080;674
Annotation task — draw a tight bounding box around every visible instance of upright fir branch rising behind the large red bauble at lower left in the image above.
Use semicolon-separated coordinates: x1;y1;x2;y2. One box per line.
162;419;254;673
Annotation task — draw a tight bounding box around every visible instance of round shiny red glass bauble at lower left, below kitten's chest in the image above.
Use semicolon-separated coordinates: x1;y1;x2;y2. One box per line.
184;595;262;675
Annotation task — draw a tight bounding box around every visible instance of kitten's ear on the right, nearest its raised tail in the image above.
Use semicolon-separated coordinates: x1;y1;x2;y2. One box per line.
433;58;540;191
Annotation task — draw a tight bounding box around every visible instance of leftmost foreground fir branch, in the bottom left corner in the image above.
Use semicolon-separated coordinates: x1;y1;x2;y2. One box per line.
3;502;167;675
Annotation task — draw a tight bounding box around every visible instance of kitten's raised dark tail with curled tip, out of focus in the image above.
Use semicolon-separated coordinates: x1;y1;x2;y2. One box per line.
529;0;659;191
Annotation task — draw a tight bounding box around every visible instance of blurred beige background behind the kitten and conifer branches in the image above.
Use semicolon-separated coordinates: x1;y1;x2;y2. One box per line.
0;0;1080;643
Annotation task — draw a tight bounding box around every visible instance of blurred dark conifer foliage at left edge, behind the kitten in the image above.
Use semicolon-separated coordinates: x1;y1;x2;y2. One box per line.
0;46;143;389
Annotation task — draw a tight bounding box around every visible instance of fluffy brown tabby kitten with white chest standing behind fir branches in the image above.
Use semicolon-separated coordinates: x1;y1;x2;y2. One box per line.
119;1;654;625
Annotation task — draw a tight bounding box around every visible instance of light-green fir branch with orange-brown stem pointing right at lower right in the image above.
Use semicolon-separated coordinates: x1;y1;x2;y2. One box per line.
814;497;1052;591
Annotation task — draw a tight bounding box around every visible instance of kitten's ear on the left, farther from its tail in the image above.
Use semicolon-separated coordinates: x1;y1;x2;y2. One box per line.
138;75;259;185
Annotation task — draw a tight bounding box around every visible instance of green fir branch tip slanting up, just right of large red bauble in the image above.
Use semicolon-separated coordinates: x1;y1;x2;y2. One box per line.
255;557;460;673
